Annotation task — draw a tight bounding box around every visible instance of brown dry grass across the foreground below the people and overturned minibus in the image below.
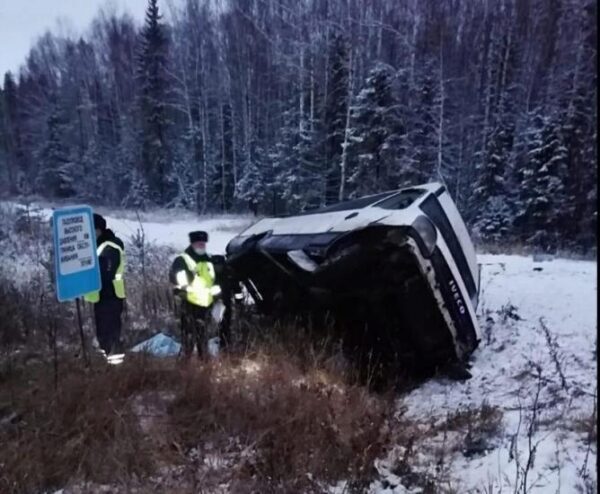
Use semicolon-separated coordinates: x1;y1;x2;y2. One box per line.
0;355;393;493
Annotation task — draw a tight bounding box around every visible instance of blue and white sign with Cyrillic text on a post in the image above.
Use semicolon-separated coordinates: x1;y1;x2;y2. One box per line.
52;206;100;302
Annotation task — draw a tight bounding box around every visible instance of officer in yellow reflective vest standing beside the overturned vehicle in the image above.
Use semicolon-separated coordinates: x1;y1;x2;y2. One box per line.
169;231;221;357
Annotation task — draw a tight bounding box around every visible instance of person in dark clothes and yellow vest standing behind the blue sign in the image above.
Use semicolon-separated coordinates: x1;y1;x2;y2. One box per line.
83;214;125;356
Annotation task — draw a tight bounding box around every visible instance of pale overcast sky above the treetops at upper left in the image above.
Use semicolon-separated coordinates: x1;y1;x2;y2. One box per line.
0;0;152;77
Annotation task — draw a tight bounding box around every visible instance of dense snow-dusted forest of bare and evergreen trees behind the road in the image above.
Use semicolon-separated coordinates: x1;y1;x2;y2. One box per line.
0;0;597;247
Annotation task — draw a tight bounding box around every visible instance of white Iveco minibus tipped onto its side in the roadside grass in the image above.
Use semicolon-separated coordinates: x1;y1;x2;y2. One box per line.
227;183;480;380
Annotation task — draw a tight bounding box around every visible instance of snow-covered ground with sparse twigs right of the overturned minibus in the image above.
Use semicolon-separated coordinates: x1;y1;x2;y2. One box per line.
373;255;597;494
